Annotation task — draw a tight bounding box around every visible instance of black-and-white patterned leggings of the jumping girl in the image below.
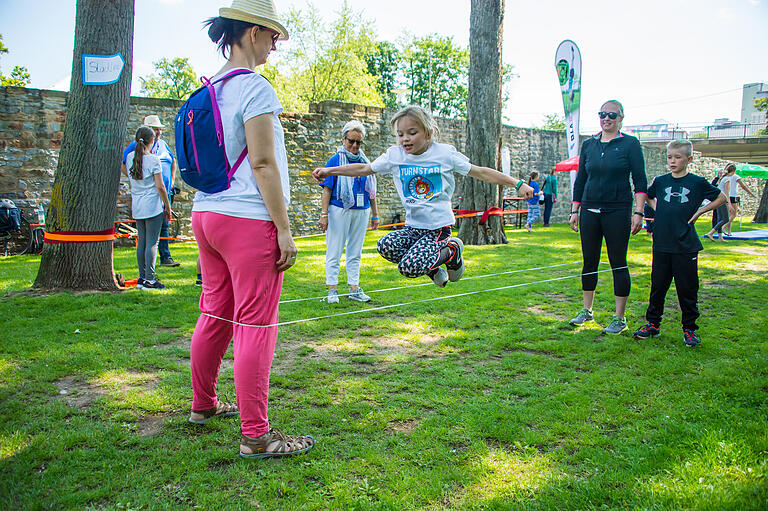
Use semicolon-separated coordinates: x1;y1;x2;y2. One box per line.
376;226;451;278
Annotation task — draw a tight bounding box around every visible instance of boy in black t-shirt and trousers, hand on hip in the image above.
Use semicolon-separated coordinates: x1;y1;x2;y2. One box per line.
634;140;727;346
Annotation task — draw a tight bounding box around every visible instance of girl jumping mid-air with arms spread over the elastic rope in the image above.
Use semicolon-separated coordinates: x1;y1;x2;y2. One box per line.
312;106;533;287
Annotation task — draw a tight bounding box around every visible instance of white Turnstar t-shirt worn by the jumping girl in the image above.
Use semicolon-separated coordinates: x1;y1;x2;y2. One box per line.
371;142;471;229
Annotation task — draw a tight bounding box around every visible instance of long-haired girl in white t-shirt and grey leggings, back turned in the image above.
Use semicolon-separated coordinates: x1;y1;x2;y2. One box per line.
126;126;171;290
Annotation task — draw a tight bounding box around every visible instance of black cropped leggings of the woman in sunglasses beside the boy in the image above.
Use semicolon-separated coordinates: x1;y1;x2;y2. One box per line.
579;207;632;296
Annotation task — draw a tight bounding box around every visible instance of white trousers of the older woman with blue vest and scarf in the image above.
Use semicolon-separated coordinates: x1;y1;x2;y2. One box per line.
325;206;371;286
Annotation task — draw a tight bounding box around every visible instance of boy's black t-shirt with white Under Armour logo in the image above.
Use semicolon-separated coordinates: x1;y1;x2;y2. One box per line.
648;173;720;254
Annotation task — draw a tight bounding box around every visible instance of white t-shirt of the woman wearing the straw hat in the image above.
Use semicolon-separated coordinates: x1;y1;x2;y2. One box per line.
192;69;291;221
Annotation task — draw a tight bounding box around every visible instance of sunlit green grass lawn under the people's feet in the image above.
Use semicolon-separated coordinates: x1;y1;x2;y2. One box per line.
0;220;768;510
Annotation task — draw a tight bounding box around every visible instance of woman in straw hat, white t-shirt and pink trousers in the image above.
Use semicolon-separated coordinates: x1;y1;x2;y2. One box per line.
189;0;315;458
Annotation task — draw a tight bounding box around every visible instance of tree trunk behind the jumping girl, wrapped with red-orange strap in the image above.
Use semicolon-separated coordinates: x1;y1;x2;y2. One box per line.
459;0;507;245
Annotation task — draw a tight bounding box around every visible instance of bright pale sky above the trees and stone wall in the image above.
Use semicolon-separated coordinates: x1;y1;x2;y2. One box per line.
0;0;768;132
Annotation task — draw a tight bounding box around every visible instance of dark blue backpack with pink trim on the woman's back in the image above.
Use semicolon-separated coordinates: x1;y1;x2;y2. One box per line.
174;69;253;193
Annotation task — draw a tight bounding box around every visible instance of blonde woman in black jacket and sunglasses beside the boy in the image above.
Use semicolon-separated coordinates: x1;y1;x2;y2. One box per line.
569;100;648;334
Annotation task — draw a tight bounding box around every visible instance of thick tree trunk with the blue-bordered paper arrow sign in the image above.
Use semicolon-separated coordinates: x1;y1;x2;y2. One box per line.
34;0;134;290
